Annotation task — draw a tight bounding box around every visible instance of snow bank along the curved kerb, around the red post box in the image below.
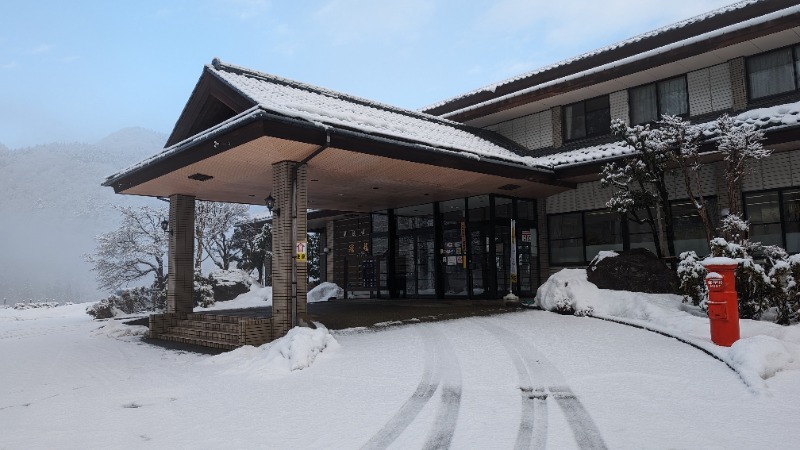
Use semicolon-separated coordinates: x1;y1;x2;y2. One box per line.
536;269;800;390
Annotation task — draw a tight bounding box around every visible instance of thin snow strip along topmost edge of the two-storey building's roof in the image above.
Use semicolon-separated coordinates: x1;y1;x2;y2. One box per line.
419;0;762;111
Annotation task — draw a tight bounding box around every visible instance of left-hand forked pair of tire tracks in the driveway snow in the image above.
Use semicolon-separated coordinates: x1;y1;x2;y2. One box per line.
361;326;461;449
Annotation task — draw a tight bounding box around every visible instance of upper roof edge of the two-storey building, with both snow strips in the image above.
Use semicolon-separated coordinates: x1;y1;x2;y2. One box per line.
420;0;798;117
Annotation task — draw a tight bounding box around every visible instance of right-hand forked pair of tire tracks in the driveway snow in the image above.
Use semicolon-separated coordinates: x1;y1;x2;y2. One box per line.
479;321;606;449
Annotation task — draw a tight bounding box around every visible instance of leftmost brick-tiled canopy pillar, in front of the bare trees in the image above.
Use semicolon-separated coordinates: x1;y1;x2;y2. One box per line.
167;194;194;313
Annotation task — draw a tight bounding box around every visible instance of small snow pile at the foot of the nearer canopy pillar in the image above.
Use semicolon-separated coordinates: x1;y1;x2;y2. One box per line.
208;324;339;374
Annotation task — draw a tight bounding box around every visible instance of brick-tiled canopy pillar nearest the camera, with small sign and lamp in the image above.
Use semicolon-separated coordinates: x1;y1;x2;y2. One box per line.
272;161;308;338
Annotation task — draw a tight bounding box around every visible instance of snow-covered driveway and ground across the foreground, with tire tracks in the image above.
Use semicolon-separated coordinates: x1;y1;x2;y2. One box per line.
0;283;800;449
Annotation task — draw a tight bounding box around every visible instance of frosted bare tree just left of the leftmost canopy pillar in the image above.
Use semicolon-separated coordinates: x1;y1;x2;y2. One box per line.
85;206;167;291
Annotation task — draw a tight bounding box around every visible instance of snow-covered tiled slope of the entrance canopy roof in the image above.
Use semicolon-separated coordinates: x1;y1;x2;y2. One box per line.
207;59;544;164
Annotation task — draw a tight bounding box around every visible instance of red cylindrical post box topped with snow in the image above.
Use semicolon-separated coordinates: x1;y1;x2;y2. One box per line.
703;258;739;347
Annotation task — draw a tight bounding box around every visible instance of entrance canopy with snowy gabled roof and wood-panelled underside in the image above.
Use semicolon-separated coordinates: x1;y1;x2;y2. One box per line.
104;59;572;212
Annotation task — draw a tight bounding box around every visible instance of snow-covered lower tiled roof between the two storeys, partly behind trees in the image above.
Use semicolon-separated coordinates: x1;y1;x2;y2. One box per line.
531;102;800;169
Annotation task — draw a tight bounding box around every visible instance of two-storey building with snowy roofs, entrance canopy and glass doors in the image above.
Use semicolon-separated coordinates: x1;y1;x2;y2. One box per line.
105;0;800;346
